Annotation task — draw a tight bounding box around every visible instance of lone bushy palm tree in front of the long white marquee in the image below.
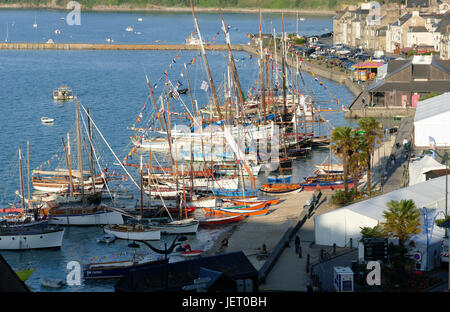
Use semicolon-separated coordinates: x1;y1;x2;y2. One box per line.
382;199;421;271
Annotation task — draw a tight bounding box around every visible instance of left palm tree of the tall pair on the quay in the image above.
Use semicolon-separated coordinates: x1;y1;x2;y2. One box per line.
331;126;354;193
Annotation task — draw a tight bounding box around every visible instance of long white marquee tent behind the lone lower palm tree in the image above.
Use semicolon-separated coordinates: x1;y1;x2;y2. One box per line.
314;176;445;269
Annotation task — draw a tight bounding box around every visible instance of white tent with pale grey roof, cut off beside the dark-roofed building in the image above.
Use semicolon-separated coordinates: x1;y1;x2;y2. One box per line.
414;92;450;147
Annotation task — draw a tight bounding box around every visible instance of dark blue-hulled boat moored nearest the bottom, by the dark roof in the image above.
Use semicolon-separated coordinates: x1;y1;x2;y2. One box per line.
83;257;166;280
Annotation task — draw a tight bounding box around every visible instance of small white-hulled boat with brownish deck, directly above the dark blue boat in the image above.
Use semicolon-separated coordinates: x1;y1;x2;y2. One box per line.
103;224;161;240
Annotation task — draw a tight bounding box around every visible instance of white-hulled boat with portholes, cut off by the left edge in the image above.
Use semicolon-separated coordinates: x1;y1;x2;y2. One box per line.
0;223;64;250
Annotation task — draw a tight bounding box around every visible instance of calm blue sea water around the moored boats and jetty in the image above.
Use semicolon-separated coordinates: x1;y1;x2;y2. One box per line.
0;10;353;291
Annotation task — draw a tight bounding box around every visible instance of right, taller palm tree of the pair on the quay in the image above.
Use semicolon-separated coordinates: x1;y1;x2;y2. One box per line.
359;117;383;194
